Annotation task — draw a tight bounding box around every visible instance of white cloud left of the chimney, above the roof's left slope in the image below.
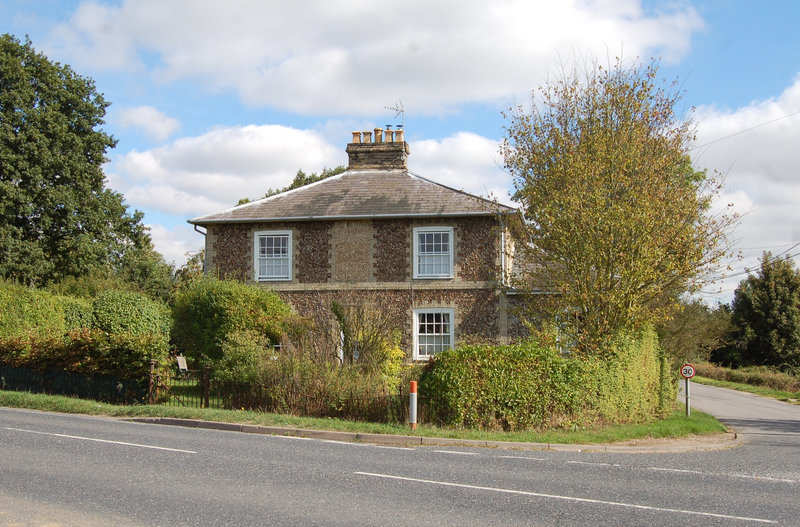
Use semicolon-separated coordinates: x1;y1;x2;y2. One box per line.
107;125;346;219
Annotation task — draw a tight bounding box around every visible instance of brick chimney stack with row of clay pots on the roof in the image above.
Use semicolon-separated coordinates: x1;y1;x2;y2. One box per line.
345;126;410;170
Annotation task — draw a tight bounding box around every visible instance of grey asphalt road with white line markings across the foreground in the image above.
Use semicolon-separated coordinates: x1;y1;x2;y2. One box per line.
0;386;800;526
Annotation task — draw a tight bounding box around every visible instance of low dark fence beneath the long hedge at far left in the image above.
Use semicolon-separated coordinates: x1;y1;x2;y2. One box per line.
0;364;148;404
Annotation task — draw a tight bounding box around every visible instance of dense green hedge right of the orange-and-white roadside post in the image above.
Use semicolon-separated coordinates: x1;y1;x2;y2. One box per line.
420;331;675;430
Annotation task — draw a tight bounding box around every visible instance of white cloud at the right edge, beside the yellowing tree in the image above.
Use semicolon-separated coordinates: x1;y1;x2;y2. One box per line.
693;76;800;301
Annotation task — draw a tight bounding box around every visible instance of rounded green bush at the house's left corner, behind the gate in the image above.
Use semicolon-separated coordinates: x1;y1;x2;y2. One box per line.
172;277;290;365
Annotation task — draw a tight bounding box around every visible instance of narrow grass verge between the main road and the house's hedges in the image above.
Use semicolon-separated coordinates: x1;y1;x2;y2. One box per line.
0;390;725;444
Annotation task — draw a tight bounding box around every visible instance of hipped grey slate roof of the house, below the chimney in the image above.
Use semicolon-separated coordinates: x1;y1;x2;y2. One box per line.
189;169;514;225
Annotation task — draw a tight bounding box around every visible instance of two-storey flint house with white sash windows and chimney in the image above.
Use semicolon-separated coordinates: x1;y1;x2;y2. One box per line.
189;128;516;360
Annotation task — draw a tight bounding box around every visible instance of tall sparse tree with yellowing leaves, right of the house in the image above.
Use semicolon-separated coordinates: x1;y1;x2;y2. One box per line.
502;60;733;350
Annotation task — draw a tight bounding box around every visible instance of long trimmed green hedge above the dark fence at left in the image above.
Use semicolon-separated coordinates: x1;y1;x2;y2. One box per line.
0;282;170;380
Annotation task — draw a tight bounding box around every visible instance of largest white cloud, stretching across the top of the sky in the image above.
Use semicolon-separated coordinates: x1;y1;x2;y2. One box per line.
51;0;703;115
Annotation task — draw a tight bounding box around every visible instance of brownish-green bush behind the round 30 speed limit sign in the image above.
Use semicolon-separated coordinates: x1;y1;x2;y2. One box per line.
656;299;731;362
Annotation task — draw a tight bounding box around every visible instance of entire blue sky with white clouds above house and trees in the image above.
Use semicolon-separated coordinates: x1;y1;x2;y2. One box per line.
0;0;800;301
